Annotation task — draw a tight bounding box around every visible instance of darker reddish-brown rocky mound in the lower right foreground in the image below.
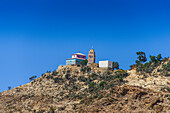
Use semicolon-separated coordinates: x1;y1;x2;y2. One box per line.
78;85;170;113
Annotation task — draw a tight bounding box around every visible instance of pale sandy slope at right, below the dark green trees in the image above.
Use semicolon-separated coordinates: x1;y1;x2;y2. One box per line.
125;59;170;92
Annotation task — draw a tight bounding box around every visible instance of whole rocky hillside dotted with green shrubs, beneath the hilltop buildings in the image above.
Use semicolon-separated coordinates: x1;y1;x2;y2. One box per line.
0;62;170;113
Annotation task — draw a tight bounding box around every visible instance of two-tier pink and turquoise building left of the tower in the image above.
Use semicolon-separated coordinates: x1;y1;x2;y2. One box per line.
66;53;86;65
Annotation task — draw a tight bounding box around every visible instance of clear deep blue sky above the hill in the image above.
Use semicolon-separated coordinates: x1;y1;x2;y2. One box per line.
0;0;170;91
